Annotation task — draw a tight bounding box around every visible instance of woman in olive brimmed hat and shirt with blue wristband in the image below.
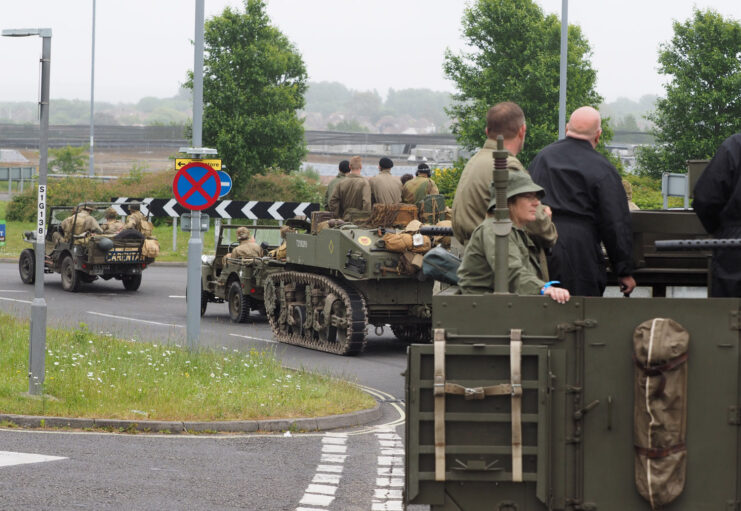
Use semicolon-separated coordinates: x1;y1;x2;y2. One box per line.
458;171;570;303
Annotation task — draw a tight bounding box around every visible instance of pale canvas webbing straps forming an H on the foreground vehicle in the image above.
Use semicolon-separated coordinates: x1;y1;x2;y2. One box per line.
433;328;523;483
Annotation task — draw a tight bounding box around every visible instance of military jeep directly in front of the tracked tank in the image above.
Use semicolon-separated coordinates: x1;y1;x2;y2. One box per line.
201;225;285;323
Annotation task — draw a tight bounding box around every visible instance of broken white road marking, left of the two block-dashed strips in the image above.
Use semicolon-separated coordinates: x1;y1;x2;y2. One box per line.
296;433;347;511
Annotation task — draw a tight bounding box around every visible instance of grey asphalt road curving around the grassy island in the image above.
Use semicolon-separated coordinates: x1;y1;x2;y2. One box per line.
0;263;420;511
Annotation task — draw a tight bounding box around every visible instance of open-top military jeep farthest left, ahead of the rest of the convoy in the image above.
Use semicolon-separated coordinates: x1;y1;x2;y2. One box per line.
18;202;154;292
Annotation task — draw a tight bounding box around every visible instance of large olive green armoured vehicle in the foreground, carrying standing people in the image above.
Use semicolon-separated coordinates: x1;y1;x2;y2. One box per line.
405;142;741;511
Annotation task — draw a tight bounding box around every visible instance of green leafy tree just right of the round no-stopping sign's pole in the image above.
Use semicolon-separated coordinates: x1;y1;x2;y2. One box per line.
191;0;306;188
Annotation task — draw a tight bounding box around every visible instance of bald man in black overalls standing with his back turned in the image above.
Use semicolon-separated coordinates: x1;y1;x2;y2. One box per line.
529;106;636;296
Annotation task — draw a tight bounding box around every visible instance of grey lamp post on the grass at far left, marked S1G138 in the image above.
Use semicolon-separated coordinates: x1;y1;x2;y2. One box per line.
2;28;51;395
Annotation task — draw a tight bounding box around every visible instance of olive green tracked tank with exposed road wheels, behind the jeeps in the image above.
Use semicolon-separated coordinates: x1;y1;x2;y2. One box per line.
265;214;433;355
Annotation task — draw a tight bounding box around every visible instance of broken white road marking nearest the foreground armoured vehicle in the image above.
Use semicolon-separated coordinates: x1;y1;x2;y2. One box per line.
371;429;404;511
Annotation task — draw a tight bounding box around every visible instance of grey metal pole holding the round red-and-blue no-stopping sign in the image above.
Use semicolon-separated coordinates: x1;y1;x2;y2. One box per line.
187;0;204;349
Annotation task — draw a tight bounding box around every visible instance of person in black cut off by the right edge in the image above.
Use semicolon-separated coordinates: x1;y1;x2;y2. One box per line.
692;133;741;297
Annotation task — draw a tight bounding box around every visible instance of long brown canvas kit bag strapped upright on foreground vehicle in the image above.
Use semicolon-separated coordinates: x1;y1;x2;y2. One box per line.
633;318;689;509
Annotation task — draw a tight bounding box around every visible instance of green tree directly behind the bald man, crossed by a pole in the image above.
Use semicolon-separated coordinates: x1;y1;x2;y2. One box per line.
443;0;612;165
